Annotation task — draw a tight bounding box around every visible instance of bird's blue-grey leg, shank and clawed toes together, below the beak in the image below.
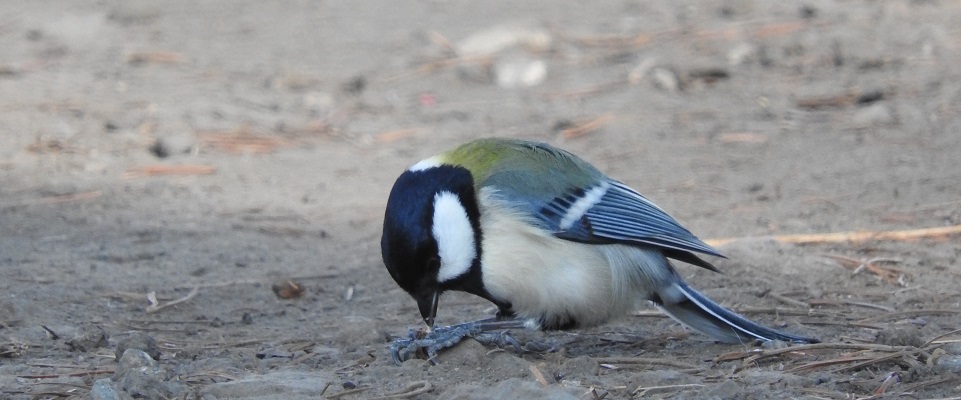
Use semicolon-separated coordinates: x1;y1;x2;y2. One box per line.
389;318;526;364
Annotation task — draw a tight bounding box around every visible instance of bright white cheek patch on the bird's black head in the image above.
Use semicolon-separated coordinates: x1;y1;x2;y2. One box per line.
431;192;477;282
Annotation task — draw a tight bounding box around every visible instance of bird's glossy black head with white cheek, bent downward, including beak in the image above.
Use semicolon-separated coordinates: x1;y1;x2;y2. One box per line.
380;160;481;328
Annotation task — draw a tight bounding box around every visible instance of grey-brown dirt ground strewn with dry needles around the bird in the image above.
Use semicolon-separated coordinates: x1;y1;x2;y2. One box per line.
0;0;961;399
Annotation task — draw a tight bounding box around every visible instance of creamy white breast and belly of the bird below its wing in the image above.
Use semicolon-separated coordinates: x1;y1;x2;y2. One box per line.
480;188;670;326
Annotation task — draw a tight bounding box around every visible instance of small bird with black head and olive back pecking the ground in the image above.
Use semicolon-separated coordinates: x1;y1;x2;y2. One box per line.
381;137;818;362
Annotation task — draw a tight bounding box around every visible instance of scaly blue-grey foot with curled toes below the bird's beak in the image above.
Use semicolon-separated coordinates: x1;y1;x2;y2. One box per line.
388;322;523;365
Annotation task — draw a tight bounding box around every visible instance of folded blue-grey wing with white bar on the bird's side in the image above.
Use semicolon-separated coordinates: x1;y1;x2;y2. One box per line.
535;180;723;271
